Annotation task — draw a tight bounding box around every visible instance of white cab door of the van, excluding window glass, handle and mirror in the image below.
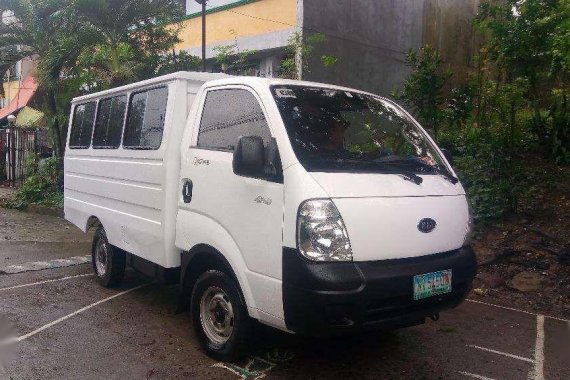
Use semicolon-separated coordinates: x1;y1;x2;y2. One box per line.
177;86;283;318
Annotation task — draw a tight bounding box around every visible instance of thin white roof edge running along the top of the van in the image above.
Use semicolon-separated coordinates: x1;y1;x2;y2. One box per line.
72;71;382;103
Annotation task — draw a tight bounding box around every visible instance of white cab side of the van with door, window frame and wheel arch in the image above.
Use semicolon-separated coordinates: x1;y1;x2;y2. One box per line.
176;81;290;328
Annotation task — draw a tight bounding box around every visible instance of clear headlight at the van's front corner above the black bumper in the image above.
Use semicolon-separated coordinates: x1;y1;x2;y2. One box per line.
297;199;352;261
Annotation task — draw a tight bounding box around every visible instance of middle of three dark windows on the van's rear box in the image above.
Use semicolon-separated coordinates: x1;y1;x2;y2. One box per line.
93;95;127;149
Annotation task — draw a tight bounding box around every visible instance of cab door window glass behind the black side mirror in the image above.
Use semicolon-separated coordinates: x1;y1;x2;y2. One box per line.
198;89;271;151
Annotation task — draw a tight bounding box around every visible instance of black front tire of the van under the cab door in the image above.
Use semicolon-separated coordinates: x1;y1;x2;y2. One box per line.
190;270;251;361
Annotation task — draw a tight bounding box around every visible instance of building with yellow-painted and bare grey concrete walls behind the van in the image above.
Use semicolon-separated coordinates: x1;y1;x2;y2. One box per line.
177;0;480;95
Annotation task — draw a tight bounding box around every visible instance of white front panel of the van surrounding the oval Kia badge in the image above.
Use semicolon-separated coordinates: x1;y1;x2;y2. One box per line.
333;196;469;261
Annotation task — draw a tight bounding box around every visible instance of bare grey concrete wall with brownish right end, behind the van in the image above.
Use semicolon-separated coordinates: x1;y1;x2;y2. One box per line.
299;0;479;95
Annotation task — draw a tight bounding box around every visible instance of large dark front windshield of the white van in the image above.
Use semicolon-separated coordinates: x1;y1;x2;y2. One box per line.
272;85;447;174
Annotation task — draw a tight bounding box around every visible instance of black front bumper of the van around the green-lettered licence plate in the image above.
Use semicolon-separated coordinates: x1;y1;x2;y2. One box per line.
283;247;477;335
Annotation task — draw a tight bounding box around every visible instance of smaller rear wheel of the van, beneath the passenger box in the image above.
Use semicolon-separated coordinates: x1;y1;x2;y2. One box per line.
91;227;127;288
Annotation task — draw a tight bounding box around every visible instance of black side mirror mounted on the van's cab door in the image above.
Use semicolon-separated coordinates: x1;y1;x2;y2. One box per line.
232;136;265;178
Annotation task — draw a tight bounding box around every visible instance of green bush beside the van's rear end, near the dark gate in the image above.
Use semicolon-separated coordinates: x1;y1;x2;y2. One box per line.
6;156;63;210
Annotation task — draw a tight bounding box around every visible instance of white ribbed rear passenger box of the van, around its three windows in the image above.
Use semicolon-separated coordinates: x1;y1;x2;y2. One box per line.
64;73;226;268
